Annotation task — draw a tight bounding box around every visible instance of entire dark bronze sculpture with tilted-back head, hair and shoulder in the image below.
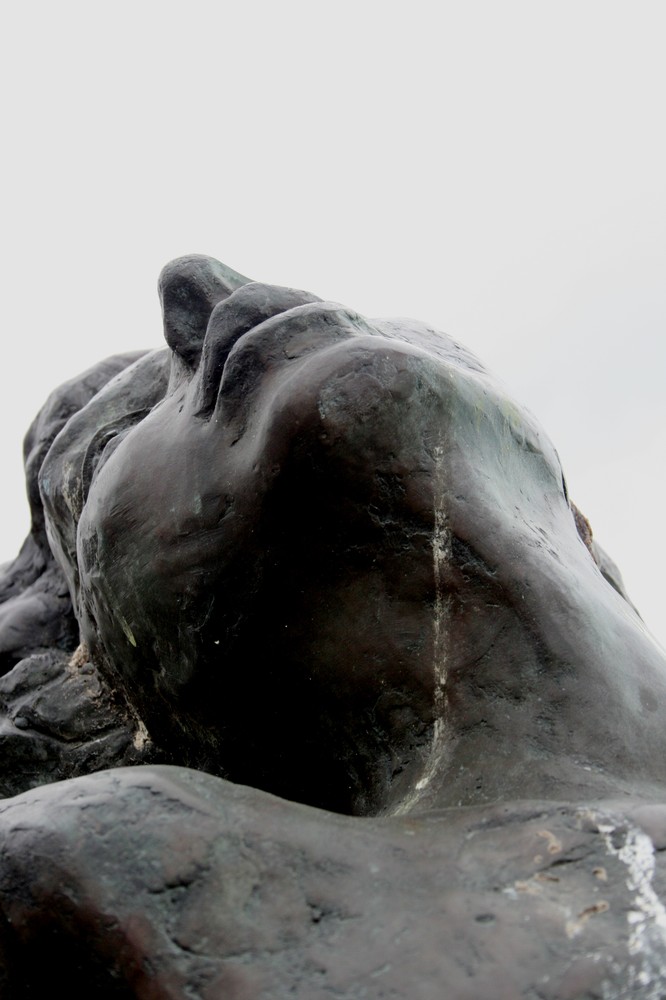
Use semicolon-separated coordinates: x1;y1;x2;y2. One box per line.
0;257;666;1000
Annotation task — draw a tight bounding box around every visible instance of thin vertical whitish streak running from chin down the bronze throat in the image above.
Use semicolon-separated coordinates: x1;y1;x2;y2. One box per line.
397;445;451;813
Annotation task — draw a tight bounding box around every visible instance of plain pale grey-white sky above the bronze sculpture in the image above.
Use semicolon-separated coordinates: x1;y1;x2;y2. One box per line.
0;0;666;644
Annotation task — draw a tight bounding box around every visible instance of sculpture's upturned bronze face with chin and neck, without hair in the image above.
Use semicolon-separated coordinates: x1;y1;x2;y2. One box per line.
41;258;666;814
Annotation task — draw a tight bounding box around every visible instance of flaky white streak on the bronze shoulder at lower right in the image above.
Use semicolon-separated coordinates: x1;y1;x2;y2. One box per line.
599;824;666;1000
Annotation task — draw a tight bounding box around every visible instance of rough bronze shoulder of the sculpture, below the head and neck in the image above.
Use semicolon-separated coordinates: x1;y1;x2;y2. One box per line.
0;767;666;1000
